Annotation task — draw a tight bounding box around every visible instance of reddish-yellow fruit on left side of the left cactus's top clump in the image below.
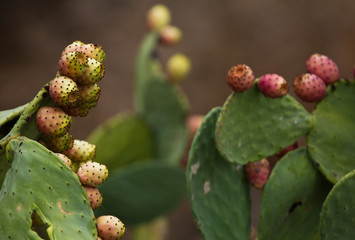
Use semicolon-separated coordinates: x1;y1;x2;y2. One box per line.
58;52;89;80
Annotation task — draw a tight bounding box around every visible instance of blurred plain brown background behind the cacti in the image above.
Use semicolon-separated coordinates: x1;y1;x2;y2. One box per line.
0;0;355;239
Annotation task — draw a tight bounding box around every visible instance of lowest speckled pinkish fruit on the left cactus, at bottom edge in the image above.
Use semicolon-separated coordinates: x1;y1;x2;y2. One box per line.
96;215;126;240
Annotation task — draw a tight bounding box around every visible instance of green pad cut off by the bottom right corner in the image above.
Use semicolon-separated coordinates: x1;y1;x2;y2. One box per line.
320;170;355;240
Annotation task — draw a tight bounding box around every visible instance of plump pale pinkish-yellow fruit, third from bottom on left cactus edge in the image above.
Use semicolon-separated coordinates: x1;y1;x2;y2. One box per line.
77;161;108;187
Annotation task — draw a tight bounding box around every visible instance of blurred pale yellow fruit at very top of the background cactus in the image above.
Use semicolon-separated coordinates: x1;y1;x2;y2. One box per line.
147;4;171;30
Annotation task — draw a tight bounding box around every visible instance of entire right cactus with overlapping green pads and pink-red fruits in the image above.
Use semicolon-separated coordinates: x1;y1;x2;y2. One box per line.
186;54;355;240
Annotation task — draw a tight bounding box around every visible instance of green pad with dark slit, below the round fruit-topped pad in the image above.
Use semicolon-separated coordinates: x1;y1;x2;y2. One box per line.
258;148;331;240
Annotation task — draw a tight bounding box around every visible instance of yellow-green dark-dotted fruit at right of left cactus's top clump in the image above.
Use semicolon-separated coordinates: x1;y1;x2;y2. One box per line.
76;58;105;85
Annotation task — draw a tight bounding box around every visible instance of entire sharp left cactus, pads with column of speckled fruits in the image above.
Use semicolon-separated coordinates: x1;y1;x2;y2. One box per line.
0;41;125;240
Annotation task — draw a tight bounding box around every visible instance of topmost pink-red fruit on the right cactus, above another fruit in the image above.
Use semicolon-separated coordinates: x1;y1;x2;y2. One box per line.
306;53;339;84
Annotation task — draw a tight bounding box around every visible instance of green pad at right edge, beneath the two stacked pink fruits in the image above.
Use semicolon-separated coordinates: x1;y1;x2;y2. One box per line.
307;80;355;183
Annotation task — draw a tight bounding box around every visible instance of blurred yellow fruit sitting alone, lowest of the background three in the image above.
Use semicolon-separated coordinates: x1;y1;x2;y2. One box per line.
167;53;191;83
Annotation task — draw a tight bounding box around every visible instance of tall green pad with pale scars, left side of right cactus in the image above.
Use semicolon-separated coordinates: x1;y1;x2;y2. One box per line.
186;108;251;240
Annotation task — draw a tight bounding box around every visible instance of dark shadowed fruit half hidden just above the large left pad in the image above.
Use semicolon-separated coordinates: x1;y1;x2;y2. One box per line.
41;133;74;153
